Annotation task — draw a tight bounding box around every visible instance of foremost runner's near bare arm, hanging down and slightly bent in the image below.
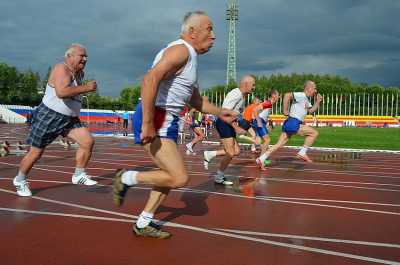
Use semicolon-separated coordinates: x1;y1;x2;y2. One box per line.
141;45;189;143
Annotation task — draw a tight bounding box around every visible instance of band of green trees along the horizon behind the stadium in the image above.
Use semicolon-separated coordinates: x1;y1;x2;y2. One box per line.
0;63;400;110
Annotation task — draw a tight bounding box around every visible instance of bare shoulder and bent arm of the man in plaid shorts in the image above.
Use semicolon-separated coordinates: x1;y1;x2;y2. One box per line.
49;64;97;98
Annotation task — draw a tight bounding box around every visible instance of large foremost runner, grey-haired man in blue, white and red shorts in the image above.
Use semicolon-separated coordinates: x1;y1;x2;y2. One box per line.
113;11;235;238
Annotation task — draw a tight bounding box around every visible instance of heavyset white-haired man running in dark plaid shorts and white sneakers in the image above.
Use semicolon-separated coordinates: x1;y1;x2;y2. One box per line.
13;44;97;196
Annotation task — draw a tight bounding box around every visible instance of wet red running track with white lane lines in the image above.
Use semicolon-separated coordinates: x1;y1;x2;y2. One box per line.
0;125;400;265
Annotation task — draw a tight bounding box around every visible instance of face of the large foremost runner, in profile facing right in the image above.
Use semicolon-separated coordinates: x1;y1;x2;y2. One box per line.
192;16;215;54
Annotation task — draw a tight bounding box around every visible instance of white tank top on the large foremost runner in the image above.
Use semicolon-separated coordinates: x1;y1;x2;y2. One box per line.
152;39;197;116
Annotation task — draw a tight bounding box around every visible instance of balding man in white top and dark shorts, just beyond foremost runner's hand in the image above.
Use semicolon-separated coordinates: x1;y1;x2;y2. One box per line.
204;75;256;185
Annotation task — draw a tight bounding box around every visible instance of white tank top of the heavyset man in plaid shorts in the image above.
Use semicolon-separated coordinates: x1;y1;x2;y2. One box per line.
42;72;82;117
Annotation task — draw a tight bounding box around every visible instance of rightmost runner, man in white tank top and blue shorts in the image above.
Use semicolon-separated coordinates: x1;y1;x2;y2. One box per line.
259;80;323;164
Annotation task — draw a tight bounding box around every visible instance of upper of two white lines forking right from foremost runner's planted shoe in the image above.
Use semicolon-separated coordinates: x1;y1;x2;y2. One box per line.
215;228;400;248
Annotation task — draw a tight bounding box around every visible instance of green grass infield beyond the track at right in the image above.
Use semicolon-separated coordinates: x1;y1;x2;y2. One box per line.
242;126;400;151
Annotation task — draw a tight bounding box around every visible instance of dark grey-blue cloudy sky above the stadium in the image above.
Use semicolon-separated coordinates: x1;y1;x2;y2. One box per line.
0;0;400;96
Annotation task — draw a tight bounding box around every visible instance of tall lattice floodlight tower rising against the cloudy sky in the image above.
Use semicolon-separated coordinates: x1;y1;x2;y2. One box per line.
226;0;239;85
